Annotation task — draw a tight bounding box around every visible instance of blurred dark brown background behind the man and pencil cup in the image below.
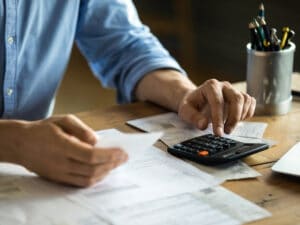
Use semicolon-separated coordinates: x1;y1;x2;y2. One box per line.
55;0;300;113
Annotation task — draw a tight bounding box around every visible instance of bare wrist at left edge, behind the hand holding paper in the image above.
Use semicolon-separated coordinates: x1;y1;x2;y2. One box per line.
0;120;27;163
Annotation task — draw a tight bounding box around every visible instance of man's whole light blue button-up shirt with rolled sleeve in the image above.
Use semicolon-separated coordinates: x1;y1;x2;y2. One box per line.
0;0;183;120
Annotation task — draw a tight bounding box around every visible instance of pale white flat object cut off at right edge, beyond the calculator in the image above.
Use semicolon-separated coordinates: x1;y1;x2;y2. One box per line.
272;142;300;176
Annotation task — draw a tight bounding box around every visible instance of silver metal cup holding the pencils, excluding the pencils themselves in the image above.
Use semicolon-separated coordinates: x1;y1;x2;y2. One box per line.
247;43;296;115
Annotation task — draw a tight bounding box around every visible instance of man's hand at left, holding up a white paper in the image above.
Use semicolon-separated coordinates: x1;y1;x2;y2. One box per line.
3;115;128;187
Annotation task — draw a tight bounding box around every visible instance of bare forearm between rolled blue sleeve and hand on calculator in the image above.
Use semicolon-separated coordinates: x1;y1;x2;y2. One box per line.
135;70;196;111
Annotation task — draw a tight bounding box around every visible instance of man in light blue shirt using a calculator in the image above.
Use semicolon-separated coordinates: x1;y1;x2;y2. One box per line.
0;0;255;186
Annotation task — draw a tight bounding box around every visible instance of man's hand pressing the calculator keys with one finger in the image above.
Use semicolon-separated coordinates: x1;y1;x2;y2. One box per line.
178;79;256;136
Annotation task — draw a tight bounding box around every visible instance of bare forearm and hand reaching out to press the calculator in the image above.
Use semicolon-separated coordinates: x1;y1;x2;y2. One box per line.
135;70;256;135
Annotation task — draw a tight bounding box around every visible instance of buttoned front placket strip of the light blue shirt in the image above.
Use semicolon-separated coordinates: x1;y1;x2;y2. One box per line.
3;0;17;117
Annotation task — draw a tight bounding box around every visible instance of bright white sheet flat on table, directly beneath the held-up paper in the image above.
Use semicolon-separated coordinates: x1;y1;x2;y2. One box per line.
71;144;223;210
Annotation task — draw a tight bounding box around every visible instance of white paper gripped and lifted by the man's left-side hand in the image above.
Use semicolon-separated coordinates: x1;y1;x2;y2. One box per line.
96;132;163;157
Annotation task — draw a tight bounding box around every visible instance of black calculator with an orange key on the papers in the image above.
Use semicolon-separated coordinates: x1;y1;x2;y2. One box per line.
168;134;269;165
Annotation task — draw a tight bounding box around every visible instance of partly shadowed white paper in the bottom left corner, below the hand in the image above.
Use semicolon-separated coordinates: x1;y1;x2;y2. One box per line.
0;163;110;225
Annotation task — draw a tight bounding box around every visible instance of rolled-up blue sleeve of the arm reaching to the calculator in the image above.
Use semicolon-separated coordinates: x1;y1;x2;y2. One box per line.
76;0;185;103
